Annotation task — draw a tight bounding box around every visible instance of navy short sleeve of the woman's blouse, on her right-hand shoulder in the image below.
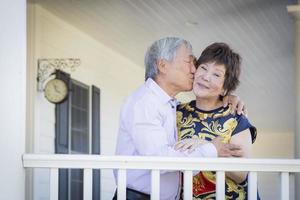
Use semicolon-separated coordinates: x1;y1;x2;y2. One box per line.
232;115;257;143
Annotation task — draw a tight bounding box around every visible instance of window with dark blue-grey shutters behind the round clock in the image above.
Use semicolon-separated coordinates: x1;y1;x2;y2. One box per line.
55;72;100;200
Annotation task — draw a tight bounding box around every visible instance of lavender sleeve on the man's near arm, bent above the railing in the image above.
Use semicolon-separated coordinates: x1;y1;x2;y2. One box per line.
130;101;217;157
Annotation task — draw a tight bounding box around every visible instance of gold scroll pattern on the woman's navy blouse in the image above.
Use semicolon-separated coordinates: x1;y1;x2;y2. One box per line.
177;104;246;200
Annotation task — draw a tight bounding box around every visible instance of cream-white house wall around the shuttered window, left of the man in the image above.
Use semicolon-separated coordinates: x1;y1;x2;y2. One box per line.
28;5;144;199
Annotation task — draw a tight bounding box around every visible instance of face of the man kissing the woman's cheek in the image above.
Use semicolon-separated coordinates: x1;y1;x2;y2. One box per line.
167;45;196;93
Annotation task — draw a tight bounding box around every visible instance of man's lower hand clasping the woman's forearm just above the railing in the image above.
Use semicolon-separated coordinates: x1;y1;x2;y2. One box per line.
211;137;243;157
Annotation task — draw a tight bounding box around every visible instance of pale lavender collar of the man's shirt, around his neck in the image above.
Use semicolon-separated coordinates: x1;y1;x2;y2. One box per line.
145;78;177;103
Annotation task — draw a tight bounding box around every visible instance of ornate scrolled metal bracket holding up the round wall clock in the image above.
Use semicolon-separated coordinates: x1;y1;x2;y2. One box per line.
37;58;81;92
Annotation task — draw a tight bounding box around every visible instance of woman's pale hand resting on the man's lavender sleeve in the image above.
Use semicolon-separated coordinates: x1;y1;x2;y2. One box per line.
174;138;208;153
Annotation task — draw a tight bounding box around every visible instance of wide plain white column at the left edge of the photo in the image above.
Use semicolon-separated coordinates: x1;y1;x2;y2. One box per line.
0;0;26;199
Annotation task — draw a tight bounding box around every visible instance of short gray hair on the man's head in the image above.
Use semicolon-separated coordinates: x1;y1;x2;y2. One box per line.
144;37;192;80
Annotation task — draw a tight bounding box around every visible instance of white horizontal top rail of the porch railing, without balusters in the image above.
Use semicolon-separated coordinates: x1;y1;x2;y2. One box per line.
23;154;300;172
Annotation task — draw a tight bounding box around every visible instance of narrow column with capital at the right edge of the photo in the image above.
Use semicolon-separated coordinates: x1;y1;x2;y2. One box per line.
287;5;300;199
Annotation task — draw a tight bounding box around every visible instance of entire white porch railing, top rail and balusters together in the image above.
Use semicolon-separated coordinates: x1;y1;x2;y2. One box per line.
23;154;300;200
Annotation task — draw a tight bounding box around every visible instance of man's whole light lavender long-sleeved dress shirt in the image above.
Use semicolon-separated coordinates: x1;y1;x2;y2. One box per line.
114;78;217;200
